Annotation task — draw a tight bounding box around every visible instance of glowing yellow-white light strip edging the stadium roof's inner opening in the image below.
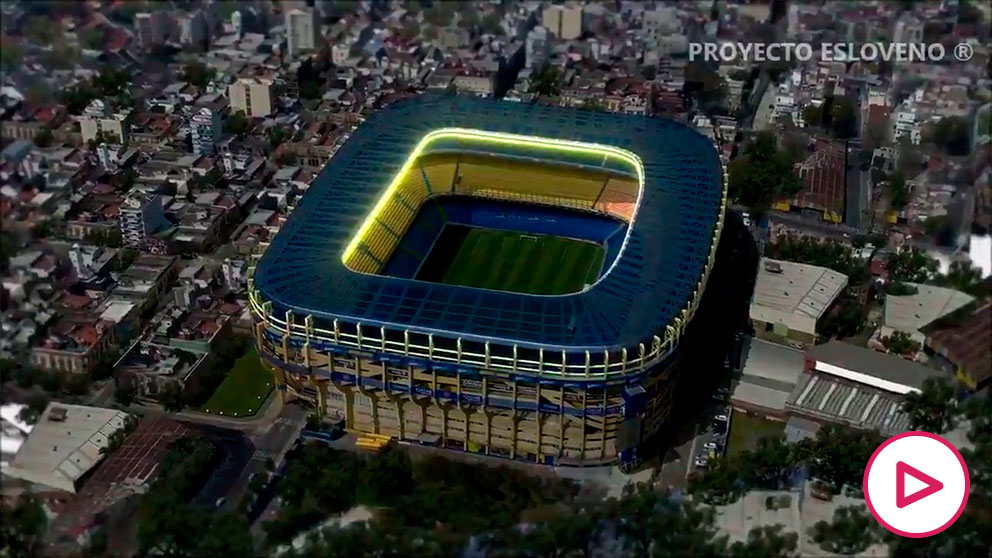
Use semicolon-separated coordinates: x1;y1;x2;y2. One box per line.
341;124;644;297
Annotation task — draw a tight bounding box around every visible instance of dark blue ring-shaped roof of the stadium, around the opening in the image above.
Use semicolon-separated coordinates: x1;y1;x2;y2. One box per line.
254;94;723;350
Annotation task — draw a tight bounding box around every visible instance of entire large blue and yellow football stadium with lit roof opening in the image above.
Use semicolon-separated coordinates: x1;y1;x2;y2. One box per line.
249;94;726;467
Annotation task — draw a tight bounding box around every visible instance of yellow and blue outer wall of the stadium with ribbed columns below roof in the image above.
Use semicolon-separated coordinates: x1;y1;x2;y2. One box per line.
249;97;726;468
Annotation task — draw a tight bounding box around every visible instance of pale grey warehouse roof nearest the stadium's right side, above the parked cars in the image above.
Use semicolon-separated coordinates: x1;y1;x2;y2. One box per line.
750;258;847;334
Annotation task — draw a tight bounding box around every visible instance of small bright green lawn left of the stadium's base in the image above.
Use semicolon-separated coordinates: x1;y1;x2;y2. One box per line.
203;347;275;417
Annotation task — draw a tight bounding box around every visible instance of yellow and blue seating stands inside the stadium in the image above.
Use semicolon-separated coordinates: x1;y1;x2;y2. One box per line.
347;151;637;277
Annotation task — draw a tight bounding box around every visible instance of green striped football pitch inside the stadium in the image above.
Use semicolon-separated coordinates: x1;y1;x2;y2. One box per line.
417;224;606;295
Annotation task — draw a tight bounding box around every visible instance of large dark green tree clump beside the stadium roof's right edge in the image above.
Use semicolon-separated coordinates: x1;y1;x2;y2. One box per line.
728;132;802;209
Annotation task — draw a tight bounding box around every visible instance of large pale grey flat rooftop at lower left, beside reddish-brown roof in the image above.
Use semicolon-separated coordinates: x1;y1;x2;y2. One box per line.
4;403;127;492
